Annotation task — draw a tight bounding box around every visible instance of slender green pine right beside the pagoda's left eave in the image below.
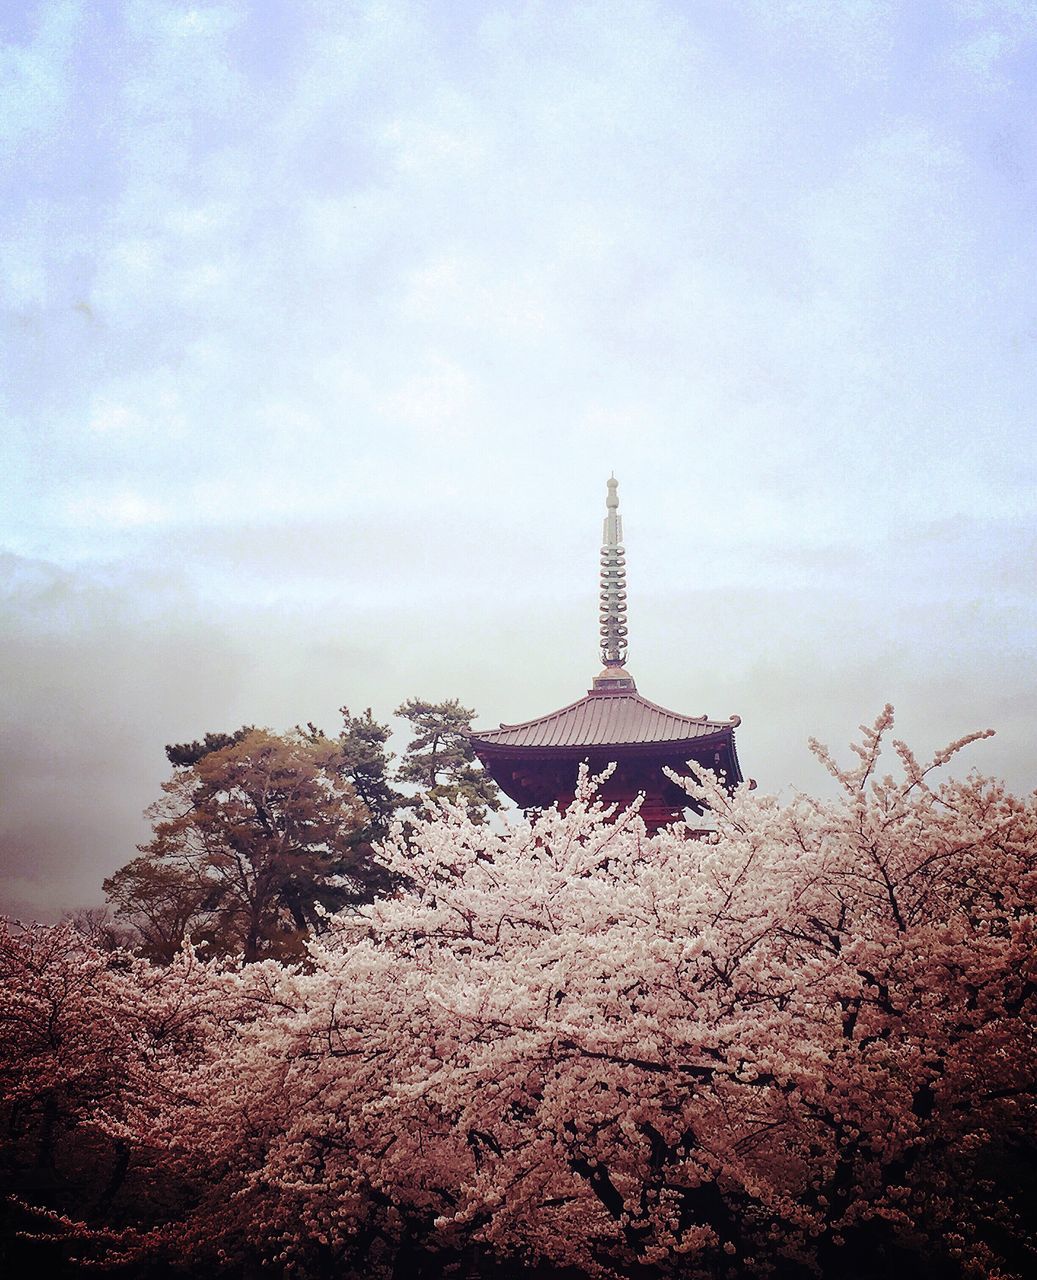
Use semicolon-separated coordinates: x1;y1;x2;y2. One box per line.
396;698;501;822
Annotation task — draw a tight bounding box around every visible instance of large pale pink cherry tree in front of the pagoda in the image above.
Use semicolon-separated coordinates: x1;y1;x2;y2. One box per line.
4;708;1037;1280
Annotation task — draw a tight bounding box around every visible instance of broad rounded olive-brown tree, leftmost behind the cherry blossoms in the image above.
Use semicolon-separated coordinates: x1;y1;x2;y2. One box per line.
105;730;378;961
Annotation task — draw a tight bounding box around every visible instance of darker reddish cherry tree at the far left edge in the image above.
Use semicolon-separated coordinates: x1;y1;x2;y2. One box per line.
0;922;290;1275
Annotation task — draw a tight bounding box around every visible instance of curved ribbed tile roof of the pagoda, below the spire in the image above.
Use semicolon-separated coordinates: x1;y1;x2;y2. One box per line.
470;690;740;748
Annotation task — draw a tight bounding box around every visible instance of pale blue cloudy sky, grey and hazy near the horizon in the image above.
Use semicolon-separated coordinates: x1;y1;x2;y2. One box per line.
0;0;1037;918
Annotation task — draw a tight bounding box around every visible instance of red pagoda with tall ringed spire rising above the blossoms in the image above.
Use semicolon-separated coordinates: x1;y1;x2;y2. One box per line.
469;476;741;832
